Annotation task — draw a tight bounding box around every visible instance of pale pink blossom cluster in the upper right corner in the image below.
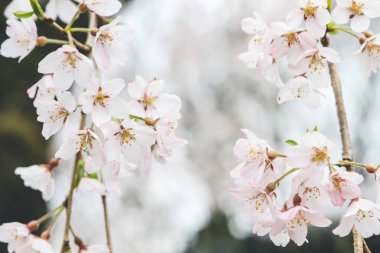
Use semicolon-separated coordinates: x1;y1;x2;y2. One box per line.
239;0;380;107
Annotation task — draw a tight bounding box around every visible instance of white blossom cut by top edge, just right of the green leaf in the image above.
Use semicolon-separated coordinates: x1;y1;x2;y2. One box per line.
46;0;77;23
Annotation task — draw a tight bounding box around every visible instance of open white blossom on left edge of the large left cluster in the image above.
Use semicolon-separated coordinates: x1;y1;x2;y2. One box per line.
37;91;80;139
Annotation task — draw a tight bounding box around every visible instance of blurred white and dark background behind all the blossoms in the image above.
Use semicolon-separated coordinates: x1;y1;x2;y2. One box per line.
0;0;380;253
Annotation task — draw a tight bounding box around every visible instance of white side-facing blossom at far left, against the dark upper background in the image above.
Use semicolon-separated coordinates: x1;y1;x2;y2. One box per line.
0;18;38;62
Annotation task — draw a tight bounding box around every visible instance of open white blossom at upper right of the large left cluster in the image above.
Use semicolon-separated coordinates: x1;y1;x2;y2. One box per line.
128;76;181;119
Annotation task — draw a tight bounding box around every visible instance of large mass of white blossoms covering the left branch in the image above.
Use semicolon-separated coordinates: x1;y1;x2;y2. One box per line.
0;0;187;253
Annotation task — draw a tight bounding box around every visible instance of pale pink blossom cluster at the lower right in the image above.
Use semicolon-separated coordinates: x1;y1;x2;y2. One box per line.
231;129;380;247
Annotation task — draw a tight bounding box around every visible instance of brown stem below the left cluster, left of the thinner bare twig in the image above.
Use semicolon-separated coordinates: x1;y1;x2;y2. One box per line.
61;113;86;253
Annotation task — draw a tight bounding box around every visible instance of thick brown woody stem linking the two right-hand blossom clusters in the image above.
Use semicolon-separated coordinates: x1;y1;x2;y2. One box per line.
322;36;363;253
